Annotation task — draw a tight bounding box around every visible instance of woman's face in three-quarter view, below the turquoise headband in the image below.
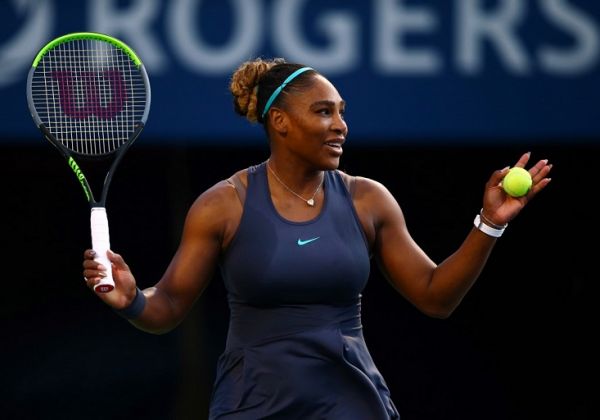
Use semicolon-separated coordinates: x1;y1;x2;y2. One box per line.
285;75;348;169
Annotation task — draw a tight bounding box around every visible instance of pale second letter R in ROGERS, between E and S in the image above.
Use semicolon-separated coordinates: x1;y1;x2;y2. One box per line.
455;0;530;74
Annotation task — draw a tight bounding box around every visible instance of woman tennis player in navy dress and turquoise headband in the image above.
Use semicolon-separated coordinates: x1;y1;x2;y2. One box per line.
83;59;551;420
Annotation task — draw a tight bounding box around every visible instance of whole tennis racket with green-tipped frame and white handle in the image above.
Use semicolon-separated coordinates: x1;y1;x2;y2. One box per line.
27;32;150;293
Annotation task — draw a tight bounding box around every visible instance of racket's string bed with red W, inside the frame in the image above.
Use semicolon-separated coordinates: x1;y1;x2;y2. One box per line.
32;39;147;156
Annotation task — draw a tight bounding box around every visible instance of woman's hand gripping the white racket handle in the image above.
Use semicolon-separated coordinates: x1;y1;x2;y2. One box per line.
83;249;136;309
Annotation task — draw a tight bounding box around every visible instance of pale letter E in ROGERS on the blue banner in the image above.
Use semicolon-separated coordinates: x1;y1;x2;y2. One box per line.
373;0;442;75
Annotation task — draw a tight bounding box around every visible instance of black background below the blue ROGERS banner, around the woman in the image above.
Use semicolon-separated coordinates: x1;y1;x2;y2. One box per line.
0;140;599;420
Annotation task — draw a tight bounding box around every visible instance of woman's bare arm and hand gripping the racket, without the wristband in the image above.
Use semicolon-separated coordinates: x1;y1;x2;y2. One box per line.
84;182;241;334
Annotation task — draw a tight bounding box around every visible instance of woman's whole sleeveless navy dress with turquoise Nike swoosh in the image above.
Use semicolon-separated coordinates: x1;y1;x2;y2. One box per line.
209;163;399;420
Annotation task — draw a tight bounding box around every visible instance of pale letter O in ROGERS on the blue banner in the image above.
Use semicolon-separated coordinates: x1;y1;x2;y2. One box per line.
166;0;265;74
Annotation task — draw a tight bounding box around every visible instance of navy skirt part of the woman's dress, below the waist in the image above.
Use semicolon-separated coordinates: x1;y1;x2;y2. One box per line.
209;305;399;420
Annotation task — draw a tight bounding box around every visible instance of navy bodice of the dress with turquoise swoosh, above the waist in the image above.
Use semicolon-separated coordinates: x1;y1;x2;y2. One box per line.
221;164;370;305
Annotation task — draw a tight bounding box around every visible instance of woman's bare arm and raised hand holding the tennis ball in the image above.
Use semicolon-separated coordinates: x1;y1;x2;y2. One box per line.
356;154;551;318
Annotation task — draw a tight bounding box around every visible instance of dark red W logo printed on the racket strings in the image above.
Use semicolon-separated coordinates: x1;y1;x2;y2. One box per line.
51;70;127;120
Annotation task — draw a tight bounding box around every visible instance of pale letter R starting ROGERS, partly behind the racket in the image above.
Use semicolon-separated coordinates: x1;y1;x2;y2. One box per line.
87;0;168;73
